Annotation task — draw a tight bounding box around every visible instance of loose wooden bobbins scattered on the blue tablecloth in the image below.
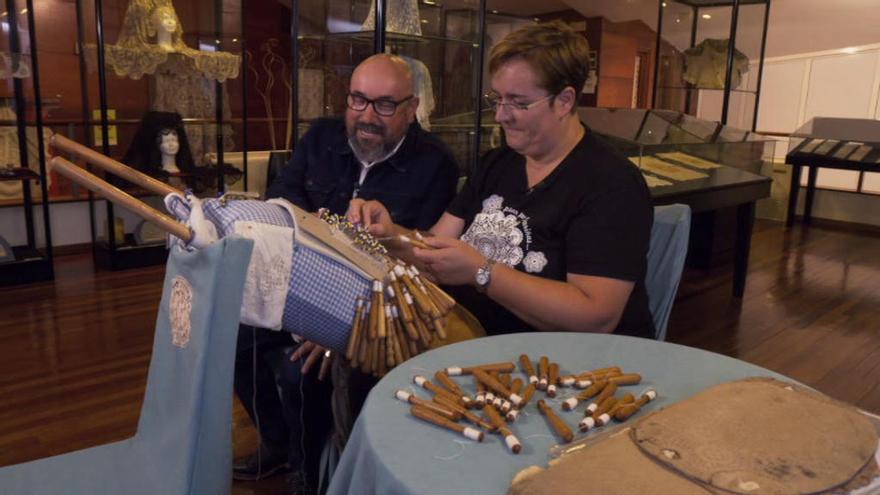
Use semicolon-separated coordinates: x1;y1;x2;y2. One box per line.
394;354;657;454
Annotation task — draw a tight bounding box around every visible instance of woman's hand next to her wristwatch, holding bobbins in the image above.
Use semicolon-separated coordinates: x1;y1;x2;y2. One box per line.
413;237;486;285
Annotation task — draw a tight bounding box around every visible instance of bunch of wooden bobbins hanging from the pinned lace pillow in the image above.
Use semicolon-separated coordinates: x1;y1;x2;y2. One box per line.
320;212;455;377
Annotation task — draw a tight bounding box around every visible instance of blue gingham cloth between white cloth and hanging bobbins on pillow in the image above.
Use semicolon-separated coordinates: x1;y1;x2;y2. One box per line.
281;246;371;352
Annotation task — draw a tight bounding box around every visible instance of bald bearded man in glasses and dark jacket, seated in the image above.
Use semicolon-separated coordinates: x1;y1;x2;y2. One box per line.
233;54;458;493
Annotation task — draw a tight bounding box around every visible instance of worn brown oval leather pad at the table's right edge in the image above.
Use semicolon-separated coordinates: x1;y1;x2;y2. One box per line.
631;378;877;495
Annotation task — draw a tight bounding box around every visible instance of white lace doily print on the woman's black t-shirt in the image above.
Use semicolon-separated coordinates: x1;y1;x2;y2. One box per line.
461;194;547;273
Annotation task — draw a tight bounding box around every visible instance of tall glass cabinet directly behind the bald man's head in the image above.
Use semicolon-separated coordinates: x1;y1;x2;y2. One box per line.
296;0;485;171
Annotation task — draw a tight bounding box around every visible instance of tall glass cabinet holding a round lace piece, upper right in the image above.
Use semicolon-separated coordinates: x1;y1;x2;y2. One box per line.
652;0;770;130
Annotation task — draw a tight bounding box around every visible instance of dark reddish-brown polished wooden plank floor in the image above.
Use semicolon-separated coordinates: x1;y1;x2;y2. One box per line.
0;221;880;494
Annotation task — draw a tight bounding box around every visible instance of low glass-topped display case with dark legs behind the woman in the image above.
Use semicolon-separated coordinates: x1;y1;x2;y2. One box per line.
579;107;776;297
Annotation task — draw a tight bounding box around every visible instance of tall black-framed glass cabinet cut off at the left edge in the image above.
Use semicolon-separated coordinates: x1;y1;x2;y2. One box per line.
0;0;54;286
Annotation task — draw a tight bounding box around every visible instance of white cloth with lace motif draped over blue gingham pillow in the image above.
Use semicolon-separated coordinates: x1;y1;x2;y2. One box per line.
235;222;294;330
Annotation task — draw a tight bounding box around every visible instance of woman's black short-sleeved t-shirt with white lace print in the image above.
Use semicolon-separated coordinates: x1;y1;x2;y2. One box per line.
447;126;654;338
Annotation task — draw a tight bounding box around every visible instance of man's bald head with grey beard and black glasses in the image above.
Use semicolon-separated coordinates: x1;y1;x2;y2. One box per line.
345;53;419;162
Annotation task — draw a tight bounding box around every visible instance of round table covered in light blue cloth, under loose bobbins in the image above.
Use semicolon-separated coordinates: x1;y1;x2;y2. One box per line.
329;332;791;495
